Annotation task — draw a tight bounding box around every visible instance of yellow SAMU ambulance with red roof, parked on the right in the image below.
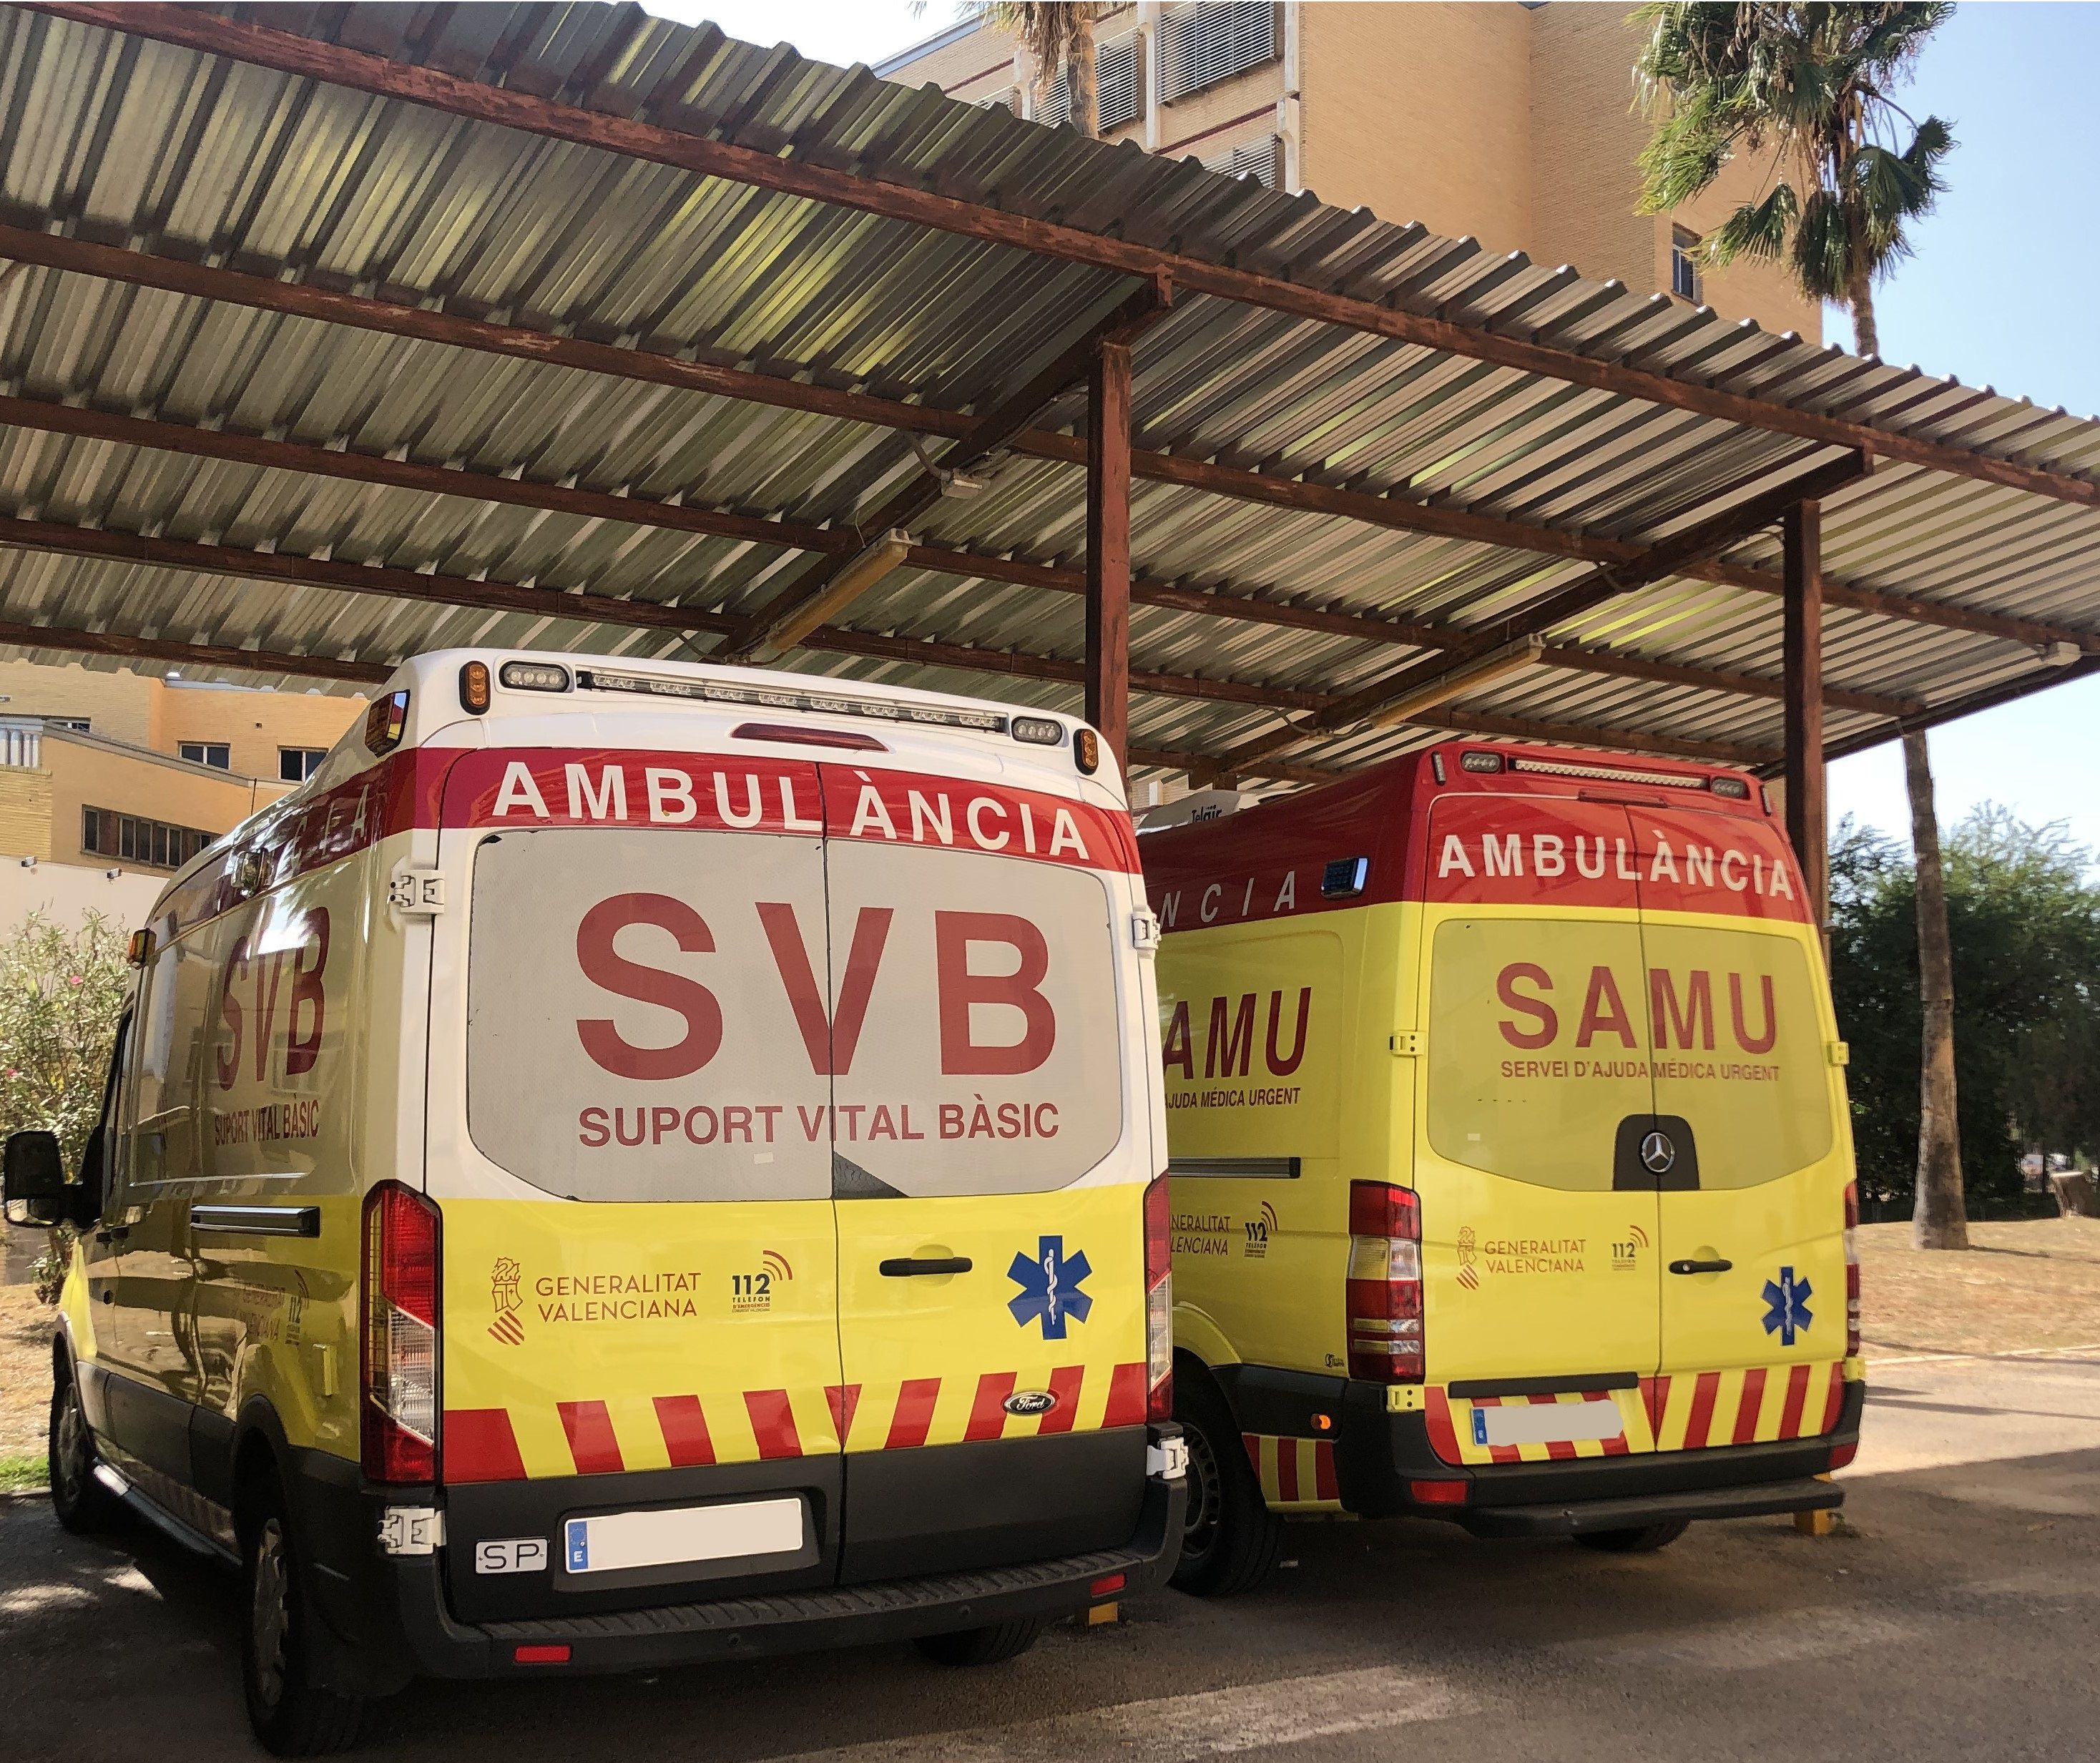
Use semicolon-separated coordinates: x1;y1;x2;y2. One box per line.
1140;743;1863;1591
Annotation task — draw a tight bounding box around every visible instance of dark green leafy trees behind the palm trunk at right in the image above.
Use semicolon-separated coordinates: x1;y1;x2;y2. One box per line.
1831;804;2100;1209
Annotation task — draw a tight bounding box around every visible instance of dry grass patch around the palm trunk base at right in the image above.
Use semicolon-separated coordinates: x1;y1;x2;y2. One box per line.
1858;1217;2100;1358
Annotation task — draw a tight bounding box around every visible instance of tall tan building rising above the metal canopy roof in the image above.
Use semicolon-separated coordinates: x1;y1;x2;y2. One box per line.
875;0;1822;342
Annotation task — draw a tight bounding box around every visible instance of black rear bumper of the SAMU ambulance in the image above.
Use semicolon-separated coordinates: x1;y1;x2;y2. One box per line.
1218;1366;1867;1536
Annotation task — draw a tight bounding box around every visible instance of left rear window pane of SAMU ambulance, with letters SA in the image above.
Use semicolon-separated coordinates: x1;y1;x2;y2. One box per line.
1428;917;1653;1188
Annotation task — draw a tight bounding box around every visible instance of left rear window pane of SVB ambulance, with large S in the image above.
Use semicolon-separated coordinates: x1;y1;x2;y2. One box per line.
466;827;832;1201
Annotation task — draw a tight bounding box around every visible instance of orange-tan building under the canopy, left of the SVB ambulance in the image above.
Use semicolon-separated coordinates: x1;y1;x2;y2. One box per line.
0;661;363;878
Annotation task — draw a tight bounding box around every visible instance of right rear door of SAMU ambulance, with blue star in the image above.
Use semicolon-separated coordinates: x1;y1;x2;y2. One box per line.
1629;804;1848;1450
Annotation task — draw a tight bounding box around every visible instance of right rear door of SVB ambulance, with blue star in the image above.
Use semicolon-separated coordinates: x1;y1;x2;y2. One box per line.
819;764;1155;1583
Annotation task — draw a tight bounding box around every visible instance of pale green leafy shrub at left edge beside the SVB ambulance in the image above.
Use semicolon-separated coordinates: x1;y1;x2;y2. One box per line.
0;913;128;1169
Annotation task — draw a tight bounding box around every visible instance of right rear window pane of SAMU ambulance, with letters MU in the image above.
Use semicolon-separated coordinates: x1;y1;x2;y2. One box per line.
1644;923;1835;1188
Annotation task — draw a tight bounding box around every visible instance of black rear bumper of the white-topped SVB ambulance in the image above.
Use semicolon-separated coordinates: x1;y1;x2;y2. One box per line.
296;1425;1187;1694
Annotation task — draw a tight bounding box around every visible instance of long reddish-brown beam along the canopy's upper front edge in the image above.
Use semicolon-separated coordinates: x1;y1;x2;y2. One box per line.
27;0;2100;508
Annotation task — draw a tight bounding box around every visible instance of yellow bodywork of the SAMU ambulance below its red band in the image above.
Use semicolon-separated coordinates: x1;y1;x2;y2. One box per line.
1159;881;1853;1509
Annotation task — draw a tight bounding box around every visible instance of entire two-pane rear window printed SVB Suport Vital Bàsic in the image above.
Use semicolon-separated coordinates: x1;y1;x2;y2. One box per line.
466;827;1126;1201
